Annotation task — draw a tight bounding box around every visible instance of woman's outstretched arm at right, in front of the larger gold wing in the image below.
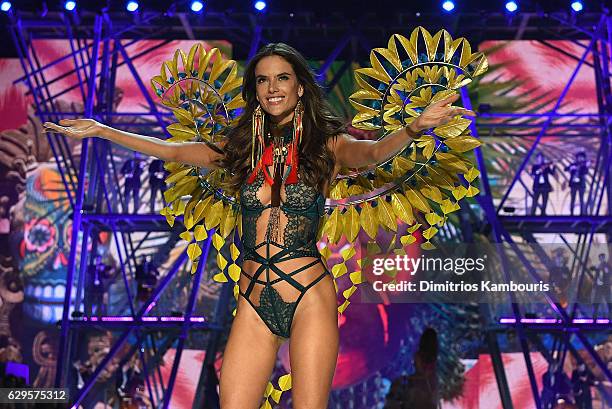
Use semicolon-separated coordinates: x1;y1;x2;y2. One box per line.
331;94;475;168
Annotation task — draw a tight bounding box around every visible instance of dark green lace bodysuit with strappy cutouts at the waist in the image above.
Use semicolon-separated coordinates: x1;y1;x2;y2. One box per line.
239;129;331;338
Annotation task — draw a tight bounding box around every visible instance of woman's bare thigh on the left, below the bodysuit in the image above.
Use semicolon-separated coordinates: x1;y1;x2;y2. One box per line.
219;297;281;409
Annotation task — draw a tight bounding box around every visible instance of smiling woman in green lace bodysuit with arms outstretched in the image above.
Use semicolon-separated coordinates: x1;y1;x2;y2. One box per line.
45;43;471;409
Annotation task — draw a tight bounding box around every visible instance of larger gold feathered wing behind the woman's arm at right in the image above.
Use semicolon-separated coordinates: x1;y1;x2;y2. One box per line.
320;27;488;313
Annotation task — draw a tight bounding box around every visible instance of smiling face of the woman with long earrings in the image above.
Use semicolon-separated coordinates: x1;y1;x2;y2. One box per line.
255;55;304;125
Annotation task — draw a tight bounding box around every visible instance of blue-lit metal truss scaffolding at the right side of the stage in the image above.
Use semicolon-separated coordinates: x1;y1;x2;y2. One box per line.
462;14;612;409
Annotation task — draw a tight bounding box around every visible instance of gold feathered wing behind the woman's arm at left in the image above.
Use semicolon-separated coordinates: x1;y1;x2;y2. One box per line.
151;44;244;282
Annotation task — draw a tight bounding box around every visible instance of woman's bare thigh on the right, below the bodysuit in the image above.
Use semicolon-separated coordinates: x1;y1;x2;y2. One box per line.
289;276;338;409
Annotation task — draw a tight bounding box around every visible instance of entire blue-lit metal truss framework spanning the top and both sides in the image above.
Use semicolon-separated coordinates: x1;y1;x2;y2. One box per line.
11;2;612;409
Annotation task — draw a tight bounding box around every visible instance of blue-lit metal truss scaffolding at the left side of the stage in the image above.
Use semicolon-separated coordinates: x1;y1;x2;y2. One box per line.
11;9;230;408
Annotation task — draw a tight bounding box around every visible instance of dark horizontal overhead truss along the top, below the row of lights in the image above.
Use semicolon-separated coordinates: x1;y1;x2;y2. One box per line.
3;6;601;60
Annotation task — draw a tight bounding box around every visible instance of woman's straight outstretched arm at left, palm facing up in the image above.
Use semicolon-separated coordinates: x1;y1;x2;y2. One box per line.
44;119;223;169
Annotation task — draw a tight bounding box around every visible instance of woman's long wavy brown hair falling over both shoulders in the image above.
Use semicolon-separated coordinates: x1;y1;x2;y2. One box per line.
219;43;346;192
